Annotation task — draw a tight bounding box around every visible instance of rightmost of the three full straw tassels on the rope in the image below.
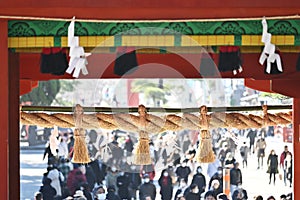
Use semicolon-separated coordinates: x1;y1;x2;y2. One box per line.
196;106;215;163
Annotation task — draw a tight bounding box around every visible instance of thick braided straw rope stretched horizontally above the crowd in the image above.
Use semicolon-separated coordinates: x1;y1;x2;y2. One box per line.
20;105;292;133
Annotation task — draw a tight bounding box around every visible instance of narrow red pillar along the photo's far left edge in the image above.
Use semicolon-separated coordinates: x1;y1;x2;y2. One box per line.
0;20;8;199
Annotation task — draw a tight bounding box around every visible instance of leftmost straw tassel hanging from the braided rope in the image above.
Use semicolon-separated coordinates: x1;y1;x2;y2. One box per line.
72;104;91;164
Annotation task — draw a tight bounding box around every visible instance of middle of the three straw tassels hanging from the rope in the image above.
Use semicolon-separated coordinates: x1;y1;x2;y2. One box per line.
134;105;152;165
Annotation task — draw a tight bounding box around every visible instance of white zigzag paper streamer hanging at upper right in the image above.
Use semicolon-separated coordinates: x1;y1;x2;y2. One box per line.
259;18;283;74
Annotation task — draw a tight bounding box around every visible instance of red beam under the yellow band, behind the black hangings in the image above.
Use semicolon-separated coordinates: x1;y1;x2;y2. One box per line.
20;53;300;80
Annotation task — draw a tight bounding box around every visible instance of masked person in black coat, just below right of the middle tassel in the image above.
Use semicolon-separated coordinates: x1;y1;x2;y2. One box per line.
158;169;173;200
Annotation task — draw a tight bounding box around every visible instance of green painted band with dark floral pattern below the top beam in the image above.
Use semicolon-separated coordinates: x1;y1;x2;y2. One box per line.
8;20;300;37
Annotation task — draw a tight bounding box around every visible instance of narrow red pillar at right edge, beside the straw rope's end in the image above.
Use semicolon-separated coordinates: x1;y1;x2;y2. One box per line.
293;98;300;199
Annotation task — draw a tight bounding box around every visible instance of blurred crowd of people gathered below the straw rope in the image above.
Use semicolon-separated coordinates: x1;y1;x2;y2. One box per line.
35;129;293;200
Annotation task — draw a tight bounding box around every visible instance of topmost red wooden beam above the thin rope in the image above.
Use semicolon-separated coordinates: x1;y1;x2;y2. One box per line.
0;0;299;20
